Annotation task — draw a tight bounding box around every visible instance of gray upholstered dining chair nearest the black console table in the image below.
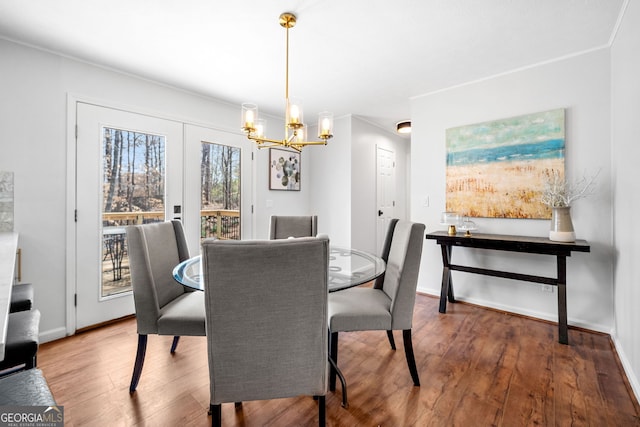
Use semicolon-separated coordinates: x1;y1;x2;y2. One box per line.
328;219;425;391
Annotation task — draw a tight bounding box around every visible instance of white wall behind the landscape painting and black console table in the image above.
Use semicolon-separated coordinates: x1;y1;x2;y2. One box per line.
410;49;613;333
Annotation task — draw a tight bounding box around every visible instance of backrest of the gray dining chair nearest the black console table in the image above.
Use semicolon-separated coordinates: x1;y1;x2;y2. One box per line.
382;220;425;330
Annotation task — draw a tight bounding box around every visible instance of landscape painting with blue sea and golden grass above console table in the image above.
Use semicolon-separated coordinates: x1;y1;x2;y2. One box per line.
446;108;565;219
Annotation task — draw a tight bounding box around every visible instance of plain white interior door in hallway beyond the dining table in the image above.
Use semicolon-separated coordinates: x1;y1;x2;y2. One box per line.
376;147;396;253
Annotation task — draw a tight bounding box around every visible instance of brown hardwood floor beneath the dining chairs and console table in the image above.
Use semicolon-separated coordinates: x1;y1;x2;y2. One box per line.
38;295;640;427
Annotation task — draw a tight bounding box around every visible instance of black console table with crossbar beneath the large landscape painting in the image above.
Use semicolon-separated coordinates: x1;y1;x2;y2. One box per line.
426;231;591;344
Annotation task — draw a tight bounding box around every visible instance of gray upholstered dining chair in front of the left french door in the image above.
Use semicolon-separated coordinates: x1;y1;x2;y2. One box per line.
126;220;205;393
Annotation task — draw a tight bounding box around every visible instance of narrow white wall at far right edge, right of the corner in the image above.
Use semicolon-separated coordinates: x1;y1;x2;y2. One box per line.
611;1;640;402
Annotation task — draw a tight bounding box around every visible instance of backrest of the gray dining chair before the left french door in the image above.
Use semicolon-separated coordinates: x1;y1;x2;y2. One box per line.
126;220;189;334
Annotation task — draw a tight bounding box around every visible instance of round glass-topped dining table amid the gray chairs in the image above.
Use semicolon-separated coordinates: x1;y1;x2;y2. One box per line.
173;246;386;408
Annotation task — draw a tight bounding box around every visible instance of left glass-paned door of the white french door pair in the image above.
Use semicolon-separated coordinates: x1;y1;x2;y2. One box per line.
75;102;184;329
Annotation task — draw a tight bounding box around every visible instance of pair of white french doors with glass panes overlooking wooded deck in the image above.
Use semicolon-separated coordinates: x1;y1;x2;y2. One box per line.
73;102;254;330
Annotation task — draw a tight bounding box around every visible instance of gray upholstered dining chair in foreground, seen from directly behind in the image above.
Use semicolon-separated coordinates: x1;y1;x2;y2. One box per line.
202;237;329;426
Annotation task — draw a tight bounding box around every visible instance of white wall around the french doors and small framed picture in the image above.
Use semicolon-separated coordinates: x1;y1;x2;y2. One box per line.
0;39;310;341
